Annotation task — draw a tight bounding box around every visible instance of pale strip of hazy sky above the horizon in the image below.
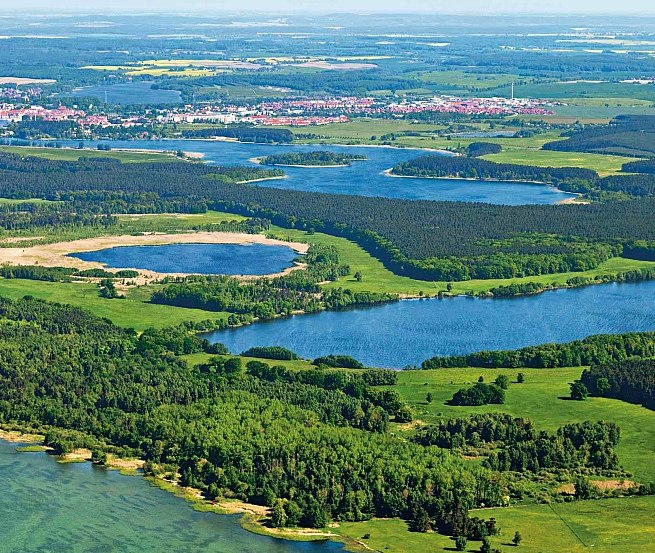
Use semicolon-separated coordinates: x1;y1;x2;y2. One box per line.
5;0;655;16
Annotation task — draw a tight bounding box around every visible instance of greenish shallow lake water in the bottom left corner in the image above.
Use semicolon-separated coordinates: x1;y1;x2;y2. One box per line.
0;441;342;553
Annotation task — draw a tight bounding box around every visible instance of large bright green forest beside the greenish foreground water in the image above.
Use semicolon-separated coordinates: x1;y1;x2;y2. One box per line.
0;299;505;527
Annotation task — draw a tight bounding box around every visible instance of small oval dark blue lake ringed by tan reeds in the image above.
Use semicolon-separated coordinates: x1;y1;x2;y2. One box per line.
70;244;298;275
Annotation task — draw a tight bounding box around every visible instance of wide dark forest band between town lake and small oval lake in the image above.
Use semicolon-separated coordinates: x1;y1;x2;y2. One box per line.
0;156;655;281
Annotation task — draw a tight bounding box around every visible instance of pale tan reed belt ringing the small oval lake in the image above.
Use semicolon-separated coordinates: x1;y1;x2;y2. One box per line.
0;232;309;281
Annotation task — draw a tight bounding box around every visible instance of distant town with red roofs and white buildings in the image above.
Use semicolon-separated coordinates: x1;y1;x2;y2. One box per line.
0;88;562;136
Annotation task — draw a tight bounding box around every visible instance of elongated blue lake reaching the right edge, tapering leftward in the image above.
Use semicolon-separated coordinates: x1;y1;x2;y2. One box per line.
207;281;655;368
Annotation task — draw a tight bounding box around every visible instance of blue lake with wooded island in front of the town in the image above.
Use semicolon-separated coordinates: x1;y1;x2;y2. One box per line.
48;140;573;205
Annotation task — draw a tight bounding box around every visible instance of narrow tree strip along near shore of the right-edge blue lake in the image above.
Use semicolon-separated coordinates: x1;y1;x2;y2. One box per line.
421;332;655;369
